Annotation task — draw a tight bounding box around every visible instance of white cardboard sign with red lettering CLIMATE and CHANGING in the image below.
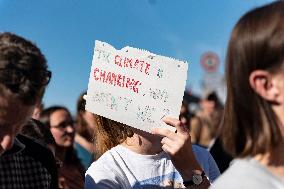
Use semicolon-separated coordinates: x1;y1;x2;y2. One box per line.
86;41;188;132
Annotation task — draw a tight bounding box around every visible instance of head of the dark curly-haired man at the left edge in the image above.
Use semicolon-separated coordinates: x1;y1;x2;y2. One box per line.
0;33;51;154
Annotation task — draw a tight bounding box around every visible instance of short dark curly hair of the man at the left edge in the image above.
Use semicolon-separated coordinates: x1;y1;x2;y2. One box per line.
0;32;51;105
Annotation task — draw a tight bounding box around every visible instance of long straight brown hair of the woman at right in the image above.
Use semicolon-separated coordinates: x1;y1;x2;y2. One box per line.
222;1;284;157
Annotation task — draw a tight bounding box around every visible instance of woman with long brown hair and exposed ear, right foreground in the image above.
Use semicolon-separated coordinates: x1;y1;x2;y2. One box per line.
212;1;284;189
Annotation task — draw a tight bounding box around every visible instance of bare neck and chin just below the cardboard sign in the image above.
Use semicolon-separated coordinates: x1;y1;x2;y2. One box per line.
121;128;162;155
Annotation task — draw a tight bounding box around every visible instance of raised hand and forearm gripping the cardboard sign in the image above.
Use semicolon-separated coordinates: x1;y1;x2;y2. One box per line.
152;117;210;189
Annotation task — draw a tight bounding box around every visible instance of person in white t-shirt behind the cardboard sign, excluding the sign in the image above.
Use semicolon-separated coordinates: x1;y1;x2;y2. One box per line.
85;116;220;189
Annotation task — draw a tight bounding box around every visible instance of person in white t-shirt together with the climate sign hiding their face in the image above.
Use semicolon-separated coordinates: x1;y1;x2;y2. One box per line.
85;41;220;189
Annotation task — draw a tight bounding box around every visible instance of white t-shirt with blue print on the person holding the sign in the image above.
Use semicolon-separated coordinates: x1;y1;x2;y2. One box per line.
85;145;220;189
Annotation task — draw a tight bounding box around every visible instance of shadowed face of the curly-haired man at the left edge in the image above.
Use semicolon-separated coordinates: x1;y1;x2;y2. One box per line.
0;96;34;155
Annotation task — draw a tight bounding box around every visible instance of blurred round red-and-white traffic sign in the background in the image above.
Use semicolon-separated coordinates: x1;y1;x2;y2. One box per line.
200;52;220;73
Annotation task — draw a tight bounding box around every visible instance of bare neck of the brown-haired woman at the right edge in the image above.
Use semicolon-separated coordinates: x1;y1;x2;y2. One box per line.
254;140;284;179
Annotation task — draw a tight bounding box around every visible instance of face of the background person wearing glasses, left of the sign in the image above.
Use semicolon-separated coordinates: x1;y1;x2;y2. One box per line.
50;110;74;147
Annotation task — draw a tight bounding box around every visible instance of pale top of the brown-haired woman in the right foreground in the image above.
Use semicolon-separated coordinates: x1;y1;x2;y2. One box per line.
210;158;284;189
